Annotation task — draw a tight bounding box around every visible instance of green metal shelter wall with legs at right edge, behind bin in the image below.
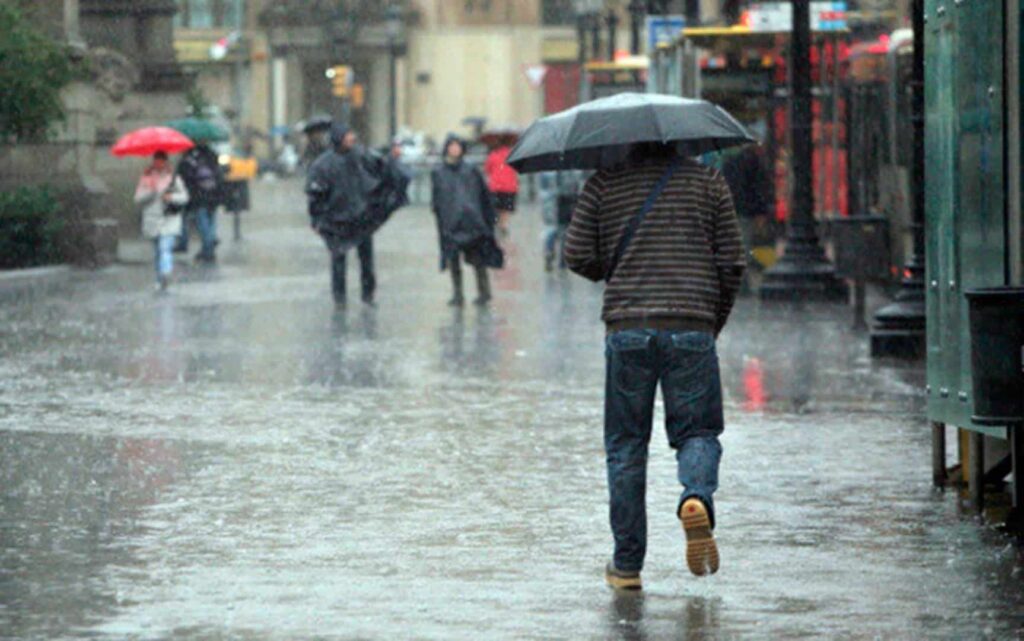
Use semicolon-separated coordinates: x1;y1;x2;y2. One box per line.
925;0;1024;518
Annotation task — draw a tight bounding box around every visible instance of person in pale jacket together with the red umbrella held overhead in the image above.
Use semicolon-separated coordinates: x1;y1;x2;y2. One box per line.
112;127;195;292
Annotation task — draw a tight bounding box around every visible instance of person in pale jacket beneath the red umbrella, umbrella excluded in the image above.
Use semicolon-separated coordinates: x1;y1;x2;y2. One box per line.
135;152;188;291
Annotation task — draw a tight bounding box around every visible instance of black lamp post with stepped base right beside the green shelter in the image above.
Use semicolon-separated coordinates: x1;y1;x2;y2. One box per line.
871;0;925;358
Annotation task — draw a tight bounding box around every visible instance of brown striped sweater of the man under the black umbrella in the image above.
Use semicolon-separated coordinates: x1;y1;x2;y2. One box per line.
565;160;746;334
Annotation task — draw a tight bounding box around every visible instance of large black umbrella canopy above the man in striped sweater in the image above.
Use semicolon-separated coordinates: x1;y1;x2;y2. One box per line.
509;93;757;173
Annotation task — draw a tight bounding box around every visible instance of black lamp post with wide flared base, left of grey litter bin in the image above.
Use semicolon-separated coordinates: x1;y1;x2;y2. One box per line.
760;0;848;302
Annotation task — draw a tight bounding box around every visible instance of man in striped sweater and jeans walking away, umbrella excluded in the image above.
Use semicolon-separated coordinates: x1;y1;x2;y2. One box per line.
565;144;744;589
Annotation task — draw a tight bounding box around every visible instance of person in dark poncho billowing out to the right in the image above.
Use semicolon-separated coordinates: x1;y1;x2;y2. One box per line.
306;124;408;305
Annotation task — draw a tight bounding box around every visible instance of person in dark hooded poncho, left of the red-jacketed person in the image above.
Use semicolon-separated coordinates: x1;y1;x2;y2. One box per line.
430;135;505;306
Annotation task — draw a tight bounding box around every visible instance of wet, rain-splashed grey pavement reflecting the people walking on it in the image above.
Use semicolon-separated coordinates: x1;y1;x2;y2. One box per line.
0;176;1024;640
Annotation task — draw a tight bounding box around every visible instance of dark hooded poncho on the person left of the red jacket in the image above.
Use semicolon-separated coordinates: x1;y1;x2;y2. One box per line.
430;135;504;269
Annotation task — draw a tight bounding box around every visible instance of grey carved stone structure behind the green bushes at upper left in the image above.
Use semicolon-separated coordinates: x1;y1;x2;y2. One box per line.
0;0;189;249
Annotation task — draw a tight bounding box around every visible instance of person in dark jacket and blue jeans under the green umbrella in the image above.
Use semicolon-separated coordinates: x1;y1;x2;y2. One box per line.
175;142;224;263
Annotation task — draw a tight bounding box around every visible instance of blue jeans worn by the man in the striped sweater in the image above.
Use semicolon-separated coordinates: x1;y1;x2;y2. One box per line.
604;330;725;571
